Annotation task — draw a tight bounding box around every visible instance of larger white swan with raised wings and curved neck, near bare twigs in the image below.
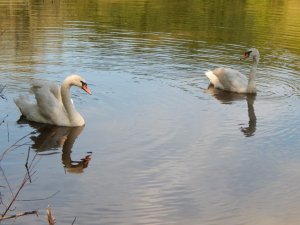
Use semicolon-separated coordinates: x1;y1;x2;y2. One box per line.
14;75;91;127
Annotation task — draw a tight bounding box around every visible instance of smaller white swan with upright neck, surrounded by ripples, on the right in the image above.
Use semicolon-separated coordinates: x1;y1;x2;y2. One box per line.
205;48;259;94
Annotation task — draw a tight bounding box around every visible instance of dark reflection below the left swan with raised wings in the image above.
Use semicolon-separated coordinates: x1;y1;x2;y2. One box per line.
18;117;91;173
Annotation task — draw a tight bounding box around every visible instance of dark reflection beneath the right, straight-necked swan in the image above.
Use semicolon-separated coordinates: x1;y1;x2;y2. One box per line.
207;85;256;137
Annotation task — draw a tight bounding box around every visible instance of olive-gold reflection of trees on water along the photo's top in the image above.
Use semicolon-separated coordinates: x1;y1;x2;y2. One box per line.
0;0;300;55
